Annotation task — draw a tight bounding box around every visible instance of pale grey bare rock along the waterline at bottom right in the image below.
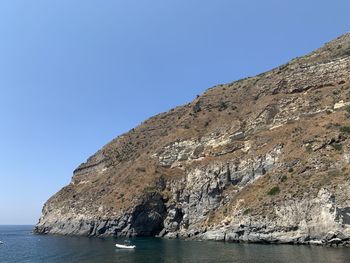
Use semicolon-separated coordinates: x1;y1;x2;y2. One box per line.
197;185;350;248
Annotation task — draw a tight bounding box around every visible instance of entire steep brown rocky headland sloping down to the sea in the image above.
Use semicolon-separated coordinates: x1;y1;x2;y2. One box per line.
35;33;350;245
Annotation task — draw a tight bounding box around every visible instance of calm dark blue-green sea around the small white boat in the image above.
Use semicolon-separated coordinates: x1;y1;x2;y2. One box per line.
0;226;350;263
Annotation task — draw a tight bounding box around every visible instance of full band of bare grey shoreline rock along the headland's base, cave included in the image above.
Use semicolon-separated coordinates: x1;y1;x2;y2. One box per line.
34;185;350;246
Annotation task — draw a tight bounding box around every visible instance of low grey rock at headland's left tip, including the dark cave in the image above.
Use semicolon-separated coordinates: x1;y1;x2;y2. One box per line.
35;193;166;236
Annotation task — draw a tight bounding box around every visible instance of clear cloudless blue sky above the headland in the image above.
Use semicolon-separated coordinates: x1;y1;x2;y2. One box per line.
0;0;350;224
